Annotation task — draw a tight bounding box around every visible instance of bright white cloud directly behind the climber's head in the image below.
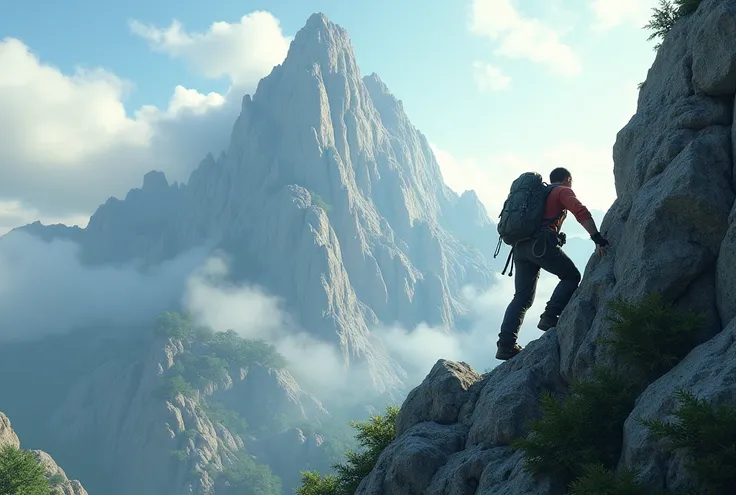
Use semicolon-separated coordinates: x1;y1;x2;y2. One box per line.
431;142;616;218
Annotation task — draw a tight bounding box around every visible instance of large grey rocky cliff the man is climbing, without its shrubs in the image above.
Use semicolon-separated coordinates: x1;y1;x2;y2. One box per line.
357;0;736;495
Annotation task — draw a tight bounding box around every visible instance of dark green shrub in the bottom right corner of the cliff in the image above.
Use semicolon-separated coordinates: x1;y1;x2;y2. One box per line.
641;389;736;495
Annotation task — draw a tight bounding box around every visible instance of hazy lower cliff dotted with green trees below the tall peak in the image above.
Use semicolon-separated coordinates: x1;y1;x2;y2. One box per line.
0;318;344;495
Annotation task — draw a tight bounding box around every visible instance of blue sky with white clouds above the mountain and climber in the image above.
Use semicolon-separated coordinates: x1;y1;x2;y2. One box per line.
0;0;655;231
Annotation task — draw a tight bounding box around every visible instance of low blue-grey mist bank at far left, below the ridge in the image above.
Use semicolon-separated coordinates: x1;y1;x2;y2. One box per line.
0;232;210;342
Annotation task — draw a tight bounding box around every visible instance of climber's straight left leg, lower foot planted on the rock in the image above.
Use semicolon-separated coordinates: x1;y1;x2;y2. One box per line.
496;251;539;360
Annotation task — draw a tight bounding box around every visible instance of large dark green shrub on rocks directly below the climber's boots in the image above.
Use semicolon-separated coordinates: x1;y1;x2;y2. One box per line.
512;368;636;480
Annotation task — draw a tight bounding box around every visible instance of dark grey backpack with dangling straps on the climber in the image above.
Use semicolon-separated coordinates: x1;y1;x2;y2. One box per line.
494;172;557;275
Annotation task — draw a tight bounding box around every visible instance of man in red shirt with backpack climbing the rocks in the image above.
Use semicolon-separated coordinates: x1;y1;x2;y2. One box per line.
496;167;609;361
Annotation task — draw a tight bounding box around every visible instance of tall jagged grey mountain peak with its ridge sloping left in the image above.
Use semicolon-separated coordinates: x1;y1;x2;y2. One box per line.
12;10;495;391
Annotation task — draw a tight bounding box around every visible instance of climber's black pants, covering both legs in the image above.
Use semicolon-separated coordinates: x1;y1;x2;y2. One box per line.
498;231;580;345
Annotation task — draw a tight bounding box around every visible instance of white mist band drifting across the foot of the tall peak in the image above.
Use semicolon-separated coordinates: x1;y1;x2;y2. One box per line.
183;252;572;401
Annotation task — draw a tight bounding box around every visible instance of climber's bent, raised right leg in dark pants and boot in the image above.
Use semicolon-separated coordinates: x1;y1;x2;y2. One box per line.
536;235;580;331
